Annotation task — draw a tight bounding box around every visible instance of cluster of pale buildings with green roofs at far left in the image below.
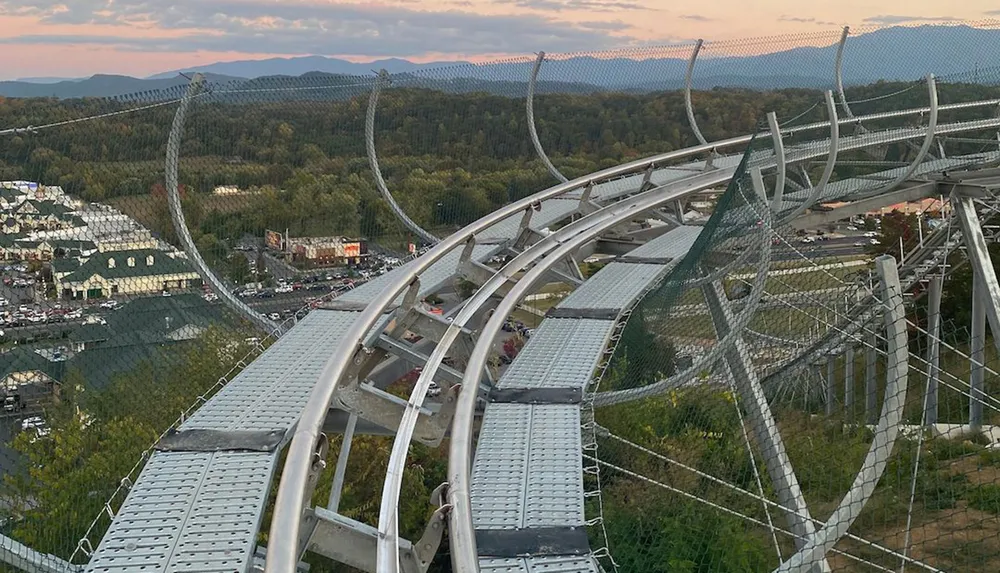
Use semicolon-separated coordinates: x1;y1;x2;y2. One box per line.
0;181;201;300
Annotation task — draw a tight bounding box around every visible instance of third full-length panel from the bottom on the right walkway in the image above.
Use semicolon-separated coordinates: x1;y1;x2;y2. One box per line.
564;263;665;310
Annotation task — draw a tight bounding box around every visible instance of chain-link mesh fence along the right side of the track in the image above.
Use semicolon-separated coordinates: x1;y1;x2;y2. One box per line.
584;58;1000;571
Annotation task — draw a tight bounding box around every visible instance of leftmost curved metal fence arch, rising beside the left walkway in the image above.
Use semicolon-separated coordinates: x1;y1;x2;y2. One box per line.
164;74;284;334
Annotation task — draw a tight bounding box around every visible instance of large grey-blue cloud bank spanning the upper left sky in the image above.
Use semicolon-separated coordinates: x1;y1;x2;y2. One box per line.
0;0;634;56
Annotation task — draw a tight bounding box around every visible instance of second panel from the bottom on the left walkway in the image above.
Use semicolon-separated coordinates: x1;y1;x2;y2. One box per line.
181;309;358;431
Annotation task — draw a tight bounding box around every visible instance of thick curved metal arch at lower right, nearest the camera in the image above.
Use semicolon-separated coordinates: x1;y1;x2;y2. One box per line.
775;256;909;573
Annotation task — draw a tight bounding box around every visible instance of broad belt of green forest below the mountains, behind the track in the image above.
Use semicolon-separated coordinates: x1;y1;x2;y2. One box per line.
0;79;990;254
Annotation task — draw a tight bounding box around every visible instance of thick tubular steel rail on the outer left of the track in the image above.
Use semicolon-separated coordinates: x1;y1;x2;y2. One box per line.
267;102;1000;572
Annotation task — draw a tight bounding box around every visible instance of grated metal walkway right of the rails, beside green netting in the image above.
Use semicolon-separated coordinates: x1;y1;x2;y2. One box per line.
471;227;701;573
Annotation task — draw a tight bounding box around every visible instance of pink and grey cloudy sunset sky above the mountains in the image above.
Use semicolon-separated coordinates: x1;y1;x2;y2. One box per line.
0;0;1000;79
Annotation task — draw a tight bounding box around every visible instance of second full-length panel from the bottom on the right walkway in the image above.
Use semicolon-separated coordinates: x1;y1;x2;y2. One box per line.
497;320;612;388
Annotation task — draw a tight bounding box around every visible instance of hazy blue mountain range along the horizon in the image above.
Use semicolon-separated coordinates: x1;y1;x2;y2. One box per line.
0;26;1000;98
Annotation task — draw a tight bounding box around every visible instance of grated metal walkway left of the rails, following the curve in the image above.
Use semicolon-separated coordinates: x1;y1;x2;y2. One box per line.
86;199;579;573
